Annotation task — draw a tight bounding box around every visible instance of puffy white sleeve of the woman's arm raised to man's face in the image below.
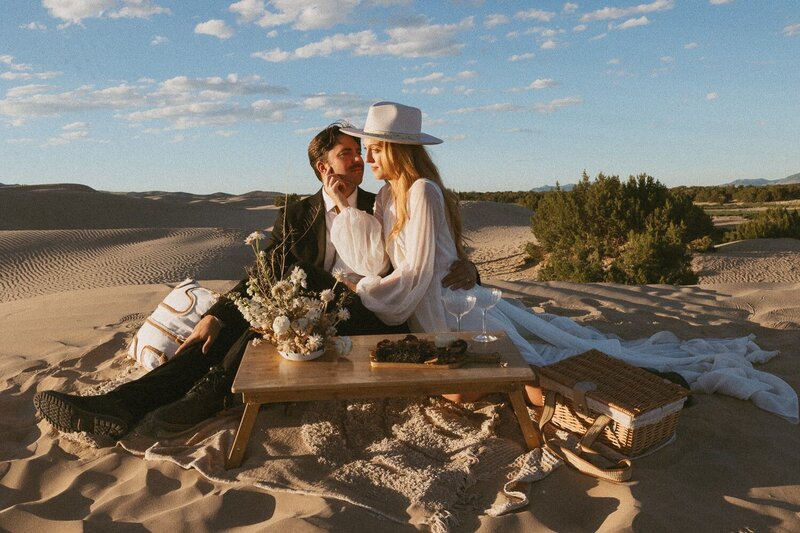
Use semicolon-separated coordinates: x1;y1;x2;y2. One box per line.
331;207;390;276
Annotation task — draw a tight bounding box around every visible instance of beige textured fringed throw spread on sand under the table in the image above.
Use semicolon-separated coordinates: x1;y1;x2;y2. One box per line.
122;396;560;531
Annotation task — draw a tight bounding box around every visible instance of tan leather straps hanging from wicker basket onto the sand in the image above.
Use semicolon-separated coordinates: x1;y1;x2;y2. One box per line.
539;390;633;483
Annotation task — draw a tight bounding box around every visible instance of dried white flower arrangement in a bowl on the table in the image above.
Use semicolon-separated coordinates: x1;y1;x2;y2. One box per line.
233;231;353;355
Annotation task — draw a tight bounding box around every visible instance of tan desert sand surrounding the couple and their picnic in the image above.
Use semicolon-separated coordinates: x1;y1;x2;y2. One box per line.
0;185;800;532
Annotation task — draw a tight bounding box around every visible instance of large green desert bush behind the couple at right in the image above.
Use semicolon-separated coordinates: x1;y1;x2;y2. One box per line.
531;173;713;284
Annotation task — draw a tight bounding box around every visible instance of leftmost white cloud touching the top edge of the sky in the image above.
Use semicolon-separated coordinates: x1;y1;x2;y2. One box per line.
42;0;171;25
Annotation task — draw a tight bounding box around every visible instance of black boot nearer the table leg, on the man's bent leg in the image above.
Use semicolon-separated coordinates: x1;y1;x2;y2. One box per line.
153;366;233;432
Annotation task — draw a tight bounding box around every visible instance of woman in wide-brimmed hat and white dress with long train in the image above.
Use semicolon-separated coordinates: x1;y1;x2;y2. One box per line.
325;102;798;423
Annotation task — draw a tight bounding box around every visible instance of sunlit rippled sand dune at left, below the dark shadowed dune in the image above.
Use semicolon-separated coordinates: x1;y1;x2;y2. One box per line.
0;228;251;301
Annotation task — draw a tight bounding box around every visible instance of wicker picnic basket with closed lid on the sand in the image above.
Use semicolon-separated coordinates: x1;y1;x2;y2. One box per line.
537;350;689;457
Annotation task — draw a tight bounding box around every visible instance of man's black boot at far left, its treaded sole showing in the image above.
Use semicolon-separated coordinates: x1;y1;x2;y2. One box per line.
33;391;135;440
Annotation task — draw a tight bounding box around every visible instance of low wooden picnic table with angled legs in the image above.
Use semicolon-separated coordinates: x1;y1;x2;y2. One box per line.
225;331;541;468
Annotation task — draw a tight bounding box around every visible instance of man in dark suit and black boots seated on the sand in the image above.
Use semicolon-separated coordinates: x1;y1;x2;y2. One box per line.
34;123;478;440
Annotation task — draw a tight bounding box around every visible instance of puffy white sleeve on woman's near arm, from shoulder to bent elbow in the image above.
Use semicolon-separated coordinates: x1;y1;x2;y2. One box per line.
356;180;444;324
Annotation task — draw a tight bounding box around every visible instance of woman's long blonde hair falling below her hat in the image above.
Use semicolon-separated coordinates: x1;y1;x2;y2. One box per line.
379;141;466;259
